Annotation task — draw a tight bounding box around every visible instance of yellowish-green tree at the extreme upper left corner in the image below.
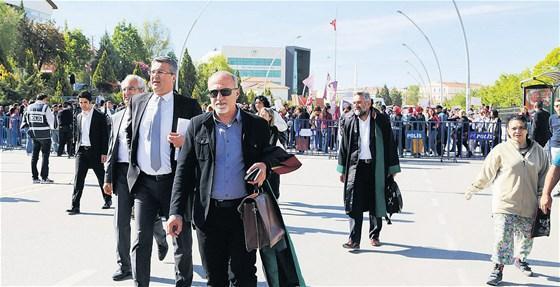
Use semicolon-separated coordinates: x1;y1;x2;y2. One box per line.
0;1;23;70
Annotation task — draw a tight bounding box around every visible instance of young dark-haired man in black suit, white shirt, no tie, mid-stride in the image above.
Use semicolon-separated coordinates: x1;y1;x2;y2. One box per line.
66;91;112;215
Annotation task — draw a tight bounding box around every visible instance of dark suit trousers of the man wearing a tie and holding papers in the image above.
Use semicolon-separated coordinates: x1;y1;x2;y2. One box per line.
132;173;193;286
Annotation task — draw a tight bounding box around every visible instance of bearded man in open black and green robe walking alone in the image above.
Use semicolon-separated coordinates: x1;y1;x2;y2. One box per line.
337;92;401;249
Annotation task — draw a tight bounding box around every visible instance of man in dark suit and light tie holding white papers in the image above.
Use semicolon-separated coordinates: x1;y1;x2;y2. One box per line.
126;57;202;286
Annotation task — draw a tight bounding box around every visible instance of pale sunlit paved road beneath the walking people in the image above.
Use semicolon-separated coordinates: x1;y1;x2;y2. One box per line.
0;151;560;286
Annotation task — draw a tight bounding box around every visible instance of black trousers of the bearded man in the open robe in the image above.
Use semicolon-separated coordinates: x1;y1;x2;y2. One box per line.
349;162;383;244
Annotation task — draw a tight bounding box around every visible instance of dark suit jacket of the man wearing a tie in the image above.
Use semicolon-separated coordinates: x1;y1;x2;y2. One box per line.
126;93;202;191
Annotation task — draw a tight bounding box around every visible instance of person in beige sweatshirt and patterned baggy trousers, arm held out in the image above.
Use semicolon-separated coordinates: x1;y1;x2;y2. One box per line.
465;115;548;286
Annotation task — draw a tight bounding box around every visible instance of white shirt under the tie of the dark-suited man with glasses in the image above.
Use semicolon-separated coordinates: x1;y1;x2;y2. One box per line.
137;91;173;175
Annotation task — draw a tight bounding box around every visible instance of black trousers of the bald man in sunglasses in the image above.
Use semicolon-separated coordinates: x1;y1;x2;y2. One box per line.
196;200;257;287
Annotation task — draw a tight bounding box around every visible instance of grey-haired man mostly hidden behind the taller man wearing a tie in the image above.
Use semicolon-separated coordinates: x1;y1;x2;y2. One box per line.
103;75;169;281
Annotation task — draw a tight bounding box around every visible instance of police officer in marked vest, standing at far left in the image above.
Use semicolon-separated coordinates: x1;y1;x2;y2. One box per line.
22;94;54;183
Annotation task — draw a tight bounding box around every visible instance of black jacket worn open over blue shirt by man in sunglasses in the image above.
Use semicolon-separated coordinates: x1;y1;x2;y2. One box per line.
169;111;275;226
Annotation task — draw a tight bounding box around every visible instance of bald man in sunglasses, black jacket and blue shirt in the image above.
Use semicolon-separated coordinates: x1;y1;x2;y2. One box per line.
167;71;272;286
